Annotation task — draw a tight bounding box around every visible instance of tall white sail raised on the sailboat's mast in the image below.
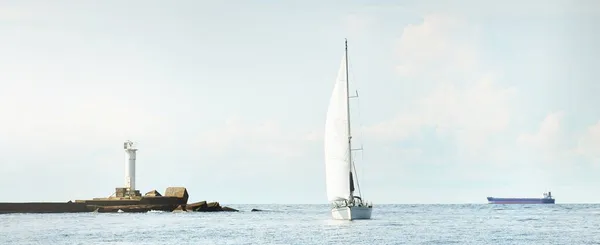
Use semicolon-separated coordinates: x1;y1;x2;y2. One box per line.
324;55;350;201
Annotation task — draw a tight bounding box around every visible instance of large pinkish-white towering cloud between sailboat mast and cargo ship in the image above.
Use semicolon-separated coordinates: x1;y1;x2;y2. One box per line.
365;15;516;151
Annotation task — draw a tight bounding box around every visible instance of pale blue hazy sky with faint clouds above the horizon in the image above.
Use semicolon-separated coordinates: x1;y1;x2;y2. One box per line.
0;0;600;204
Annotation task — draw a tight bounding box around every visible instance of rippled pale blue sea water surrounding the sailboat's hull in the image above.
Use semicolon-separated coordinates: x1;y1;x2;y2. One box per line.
0;204;600;244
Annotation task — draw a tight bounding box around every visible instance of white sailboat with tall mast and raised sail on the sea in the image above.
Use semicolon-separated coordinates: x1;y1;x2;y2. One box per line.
324;40;373;220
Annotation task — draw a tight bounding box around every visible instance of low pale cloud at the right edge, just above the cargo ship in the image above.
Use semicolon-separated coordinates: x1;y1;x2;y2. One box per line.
507;111;600;193
